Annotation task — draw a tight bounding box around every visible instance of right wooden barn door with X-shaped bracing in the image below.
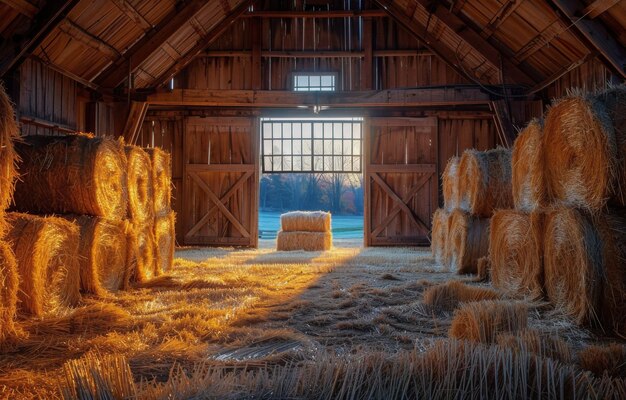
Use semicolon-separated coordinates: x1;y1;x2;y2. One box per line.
364;118;438;246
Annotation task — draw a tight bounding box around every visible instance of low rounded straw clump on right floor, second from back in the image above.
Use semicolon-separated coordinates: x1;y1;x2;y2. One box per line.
448;301;528;343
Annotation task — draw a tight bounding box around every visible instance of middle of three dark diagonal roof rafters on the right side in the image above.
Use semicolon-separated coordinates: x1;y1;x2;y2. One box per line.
417;0;537;85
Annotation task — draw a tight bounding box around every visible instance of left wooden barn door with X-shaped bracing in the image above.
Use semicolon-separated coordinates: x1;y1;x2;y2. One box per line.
183;117;259;247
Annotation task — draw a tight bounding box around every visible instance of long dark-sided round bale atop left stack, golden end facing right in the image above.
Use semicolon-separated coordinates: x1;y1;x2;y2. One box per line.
15;135;128;219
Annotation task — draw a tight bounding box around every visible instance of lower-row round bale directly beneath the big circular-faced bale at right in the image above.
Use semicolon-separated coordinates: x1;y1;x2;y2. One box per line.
543;208;604;324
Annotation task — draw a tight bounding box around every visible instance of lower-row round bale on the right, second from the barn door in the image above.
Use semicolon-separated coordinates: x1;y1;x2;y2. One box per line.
447;210;489;274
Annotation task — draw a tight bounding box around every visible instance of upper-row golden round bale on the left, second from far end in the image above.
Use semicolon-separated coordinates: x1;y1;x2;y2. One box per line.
124;146;154;224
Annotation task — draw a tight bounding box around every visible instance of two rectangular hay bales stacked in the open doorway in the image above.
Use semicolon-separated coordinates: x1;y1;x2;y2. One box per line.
276;211;332;251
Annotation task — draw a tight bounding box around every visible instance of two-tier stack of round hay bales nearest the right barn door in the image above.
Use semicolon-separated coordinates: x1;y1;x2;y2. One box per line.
432;148;513;274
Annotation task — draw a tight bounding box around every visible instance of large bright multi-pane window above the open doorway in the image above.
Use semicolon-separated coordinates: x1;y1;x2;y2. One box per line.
261;118;363;172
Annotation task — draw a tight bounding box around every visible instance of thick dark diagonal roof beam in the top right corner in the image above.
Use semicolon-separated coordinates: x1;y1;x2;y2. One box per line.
552;0;626;78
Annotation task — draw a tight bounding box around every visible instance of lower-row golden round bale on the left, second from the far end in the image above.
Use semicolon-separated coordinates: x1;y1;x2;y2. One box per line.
124;224;157;287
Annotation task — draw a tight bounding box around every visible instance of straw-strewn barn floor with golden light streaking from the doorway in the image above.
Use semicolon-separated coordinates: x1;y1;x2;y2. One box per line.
0;241;608;398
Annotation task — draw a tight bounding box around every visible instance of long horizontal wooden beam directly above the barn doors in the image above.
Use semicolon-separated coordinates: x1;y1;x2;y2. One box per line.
146;88;490;109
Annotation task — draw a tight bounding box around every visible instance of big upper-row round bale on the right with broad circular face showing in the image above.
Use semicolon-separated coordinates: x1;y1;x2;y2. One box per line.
542;94;626;212
